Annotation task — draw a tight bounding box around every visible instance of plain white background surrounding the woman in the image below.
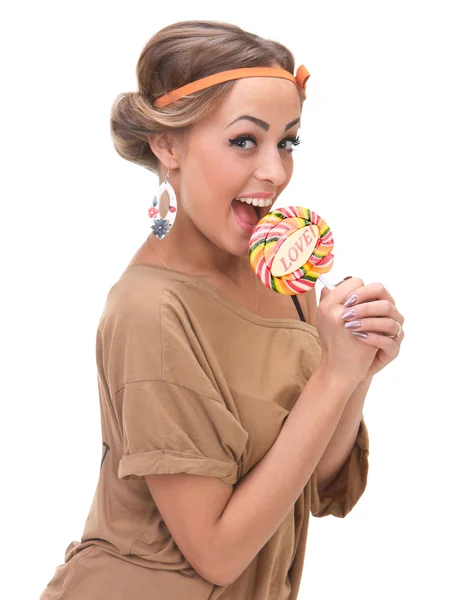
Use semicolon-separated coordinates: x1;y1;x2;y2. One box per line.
0;0;459;600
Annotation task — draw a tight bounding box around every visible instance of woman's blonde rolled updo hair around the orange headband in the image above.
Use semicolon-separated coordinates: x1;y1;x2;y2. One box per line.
110;21;303;175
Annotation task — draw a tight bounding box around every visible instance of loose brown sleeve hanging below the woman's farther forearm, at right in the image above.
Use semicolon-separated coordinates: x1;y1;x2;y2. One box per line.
310;417;369;518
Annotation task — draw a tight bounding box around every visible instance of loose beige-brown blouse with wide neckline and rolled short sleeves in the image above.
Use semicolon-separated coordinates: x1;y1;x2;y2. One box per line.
41;264;369;600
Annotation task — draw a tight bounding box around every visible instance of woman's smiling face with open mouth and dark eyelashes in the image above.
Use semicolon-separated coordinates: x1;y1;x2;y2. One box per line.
174;77;301;256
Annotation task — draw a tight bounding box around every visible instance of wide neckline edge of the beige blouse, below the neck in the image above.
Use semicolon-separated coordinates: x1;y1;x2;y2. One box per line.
124;262;319;339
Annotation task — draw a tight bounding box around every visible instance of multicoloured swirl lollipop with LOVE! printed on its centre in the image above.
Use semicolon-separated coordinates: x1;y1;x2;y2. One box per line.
249;206;335;296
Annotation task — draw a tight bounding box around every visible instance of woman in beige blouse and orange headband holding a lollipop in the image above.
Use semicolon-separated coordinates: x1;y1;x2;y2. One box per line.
41;21;404;600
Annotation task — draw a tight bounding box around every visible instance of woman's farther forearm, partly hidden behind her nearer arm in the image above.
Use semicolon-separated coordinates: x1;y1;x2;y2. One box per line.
316;378;372;493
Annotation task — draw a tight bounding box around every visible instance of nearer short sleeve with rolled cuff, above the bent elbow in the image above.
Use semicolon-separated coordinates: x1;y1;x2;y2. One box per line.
118;380;248;484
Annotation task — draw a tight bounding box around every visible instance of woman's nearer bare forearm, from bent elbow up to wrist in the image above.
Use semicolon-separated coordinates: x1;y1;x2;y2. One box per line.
211;367;355;583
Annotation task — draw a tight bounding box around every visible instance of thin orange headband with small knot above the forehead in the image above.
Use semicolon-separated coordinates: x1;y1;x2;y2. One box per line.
153;65;309;108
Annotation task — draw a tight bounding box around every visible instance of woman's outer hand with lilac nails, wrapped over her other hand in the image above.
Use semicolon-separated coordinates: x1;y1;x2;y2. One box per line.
341;283;405;379
